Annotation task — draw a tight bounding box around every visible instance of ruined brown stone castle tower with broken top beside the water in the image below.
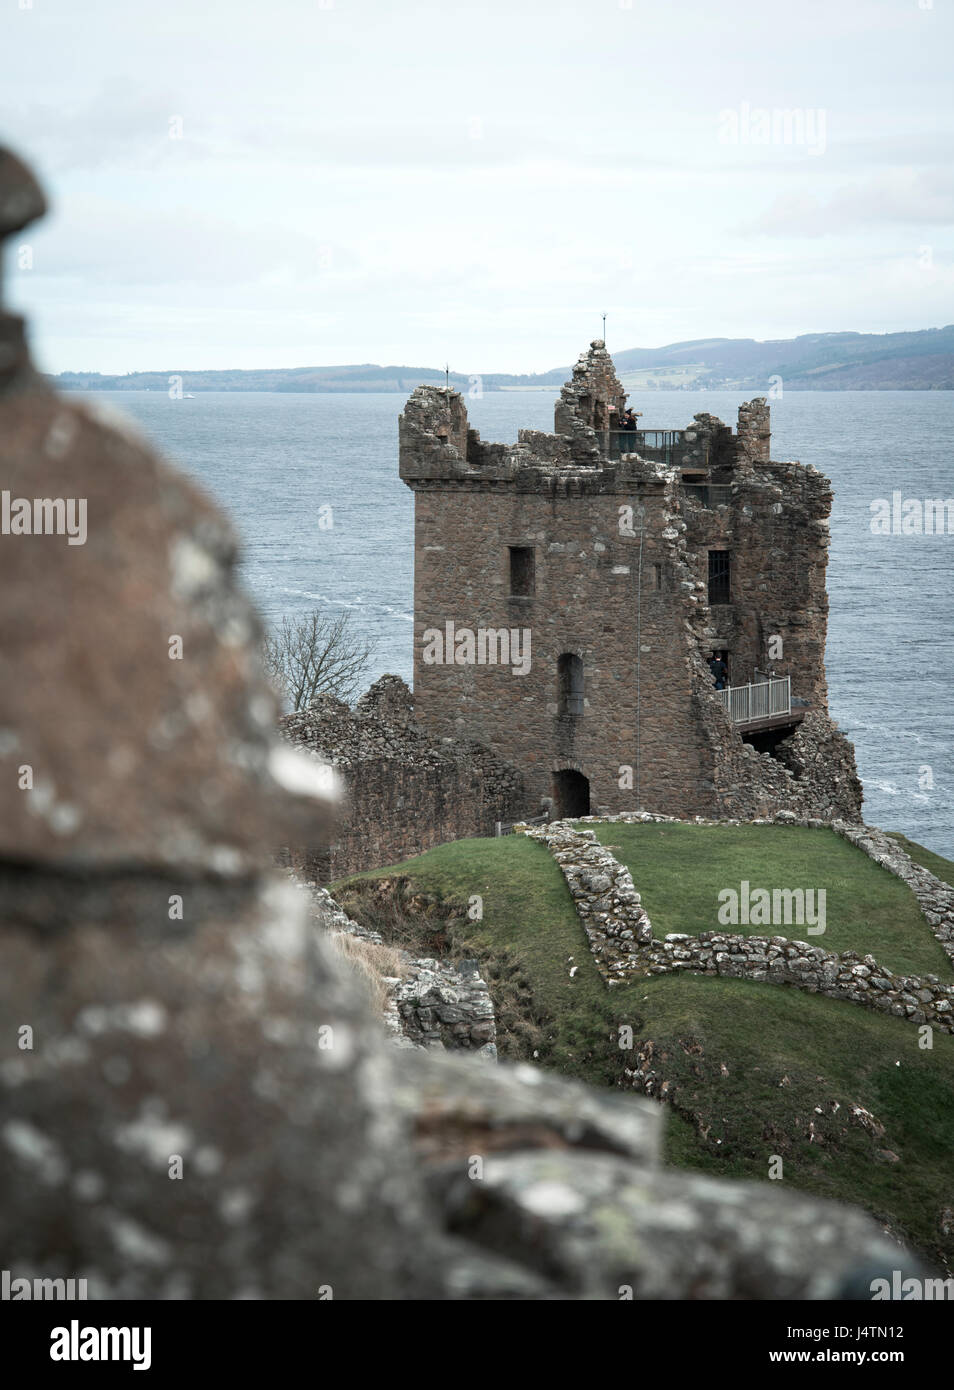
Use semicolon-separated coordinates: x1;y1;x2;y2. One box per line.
399;341;861;819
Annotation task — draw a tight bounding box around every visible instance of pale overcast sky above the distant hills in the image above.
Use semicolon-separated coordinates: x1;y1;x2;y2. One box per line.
0;0;954;373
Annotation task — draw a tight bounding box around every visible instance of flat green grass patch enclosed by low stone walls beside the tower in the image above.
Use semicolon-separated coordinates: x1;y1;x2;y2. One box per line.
590;824;953;980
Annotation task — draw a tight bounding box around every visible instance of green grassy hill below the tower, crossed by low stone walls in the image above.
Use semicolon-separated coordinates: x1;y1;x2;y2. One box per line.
332;826;954;1270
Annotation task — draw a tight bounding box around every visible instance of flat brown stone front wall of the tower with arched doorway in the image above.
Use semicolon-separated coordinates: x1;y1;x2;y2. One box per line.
414;463;715;813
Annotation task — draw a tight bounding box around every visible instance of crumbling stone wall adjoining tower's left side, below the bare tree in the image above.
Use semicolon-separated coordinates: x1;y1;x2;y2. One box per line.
280;676;524;883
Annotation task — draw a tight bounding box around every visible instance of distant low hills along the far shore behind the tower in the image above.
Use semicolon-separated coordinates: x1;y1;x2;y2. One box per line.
51;324;954;396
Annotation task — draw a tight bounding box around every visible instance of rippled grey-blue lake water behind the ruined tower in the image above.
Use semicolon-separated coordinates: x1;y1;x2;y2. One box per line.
82;391;954;858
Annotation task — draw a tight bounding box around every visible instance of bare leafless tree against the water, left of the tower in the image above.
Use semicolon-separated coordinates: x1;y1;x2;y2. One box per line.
263;609;374;710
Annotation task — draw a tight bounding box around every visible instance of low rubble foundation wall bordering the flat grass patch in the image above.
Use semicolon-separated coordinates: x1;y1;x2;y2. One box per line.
523;813;954;1033
